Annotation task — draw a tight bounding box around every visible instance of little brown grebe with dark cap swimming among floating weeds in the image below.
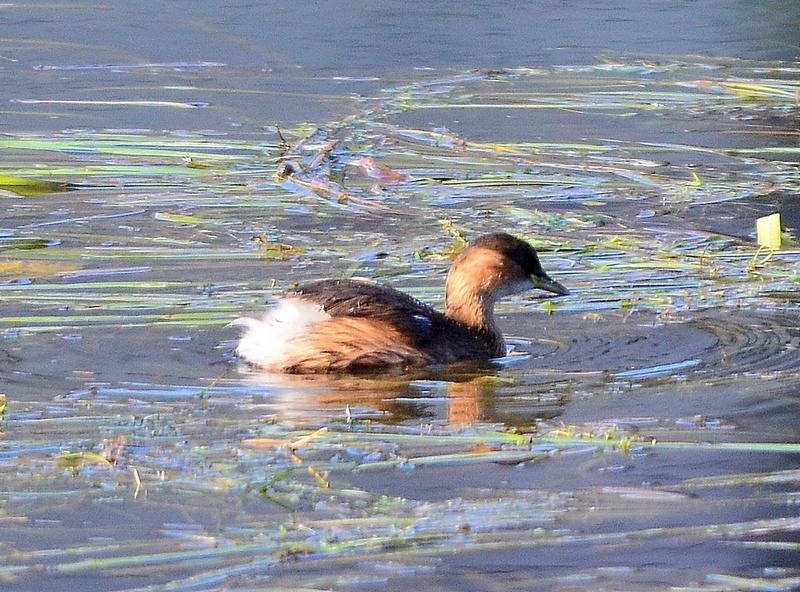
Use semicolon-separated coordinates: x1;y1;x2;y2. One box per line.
233;233;569;374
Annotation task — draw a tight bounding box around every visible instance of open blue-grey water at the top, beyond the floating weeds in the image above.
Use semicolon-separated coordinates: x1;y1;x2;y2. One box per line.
0;0;800;130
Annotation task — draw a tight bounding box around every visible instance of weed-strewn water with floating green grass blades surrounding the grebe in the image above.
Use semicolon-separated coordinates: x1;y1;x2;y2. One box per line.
0;57;800;590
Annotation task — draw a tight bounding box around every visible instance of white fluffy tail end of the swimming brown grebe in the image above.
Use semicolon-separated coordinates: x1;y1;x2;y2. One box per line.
231;298;330;369
